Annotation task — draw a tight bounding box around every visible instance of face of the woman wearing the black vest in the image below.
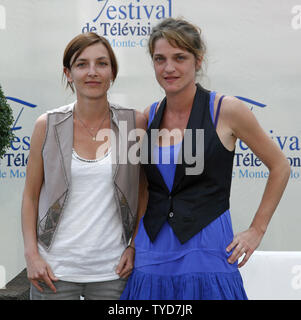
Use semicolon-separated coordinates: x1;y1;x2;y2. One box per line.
153;38;201;94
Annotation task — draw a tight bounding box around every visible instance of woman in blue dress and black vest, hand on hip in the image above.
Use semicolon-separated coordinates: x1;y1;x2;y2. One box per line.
121;18;290;300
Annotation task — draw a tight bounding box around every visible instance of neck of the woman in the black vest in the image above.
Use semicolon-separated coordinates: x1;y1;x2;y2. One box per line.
166;83;196;113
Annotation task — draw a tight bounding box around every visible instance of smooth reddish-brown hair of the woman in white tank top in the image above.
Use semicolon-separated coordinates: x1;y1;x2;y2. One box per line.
63;32;118;92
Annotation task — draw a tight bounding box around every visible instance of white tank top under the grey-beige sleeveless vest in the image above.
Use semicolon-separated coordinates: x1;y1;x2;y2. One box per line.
38;150;125;282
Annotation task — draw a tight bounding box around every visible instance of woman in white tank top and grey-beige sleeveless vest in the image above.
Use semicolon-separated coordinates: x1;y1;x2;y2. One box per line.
22;33;145;300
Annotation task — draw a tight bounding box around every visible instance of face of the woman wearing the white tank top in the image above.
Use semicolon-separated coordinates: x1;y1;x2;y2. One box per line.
64;43;113;99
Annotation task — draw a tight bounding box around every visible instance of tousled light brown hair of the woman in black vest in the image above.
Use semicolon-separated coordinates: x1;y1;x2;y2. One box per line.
148;18;206;59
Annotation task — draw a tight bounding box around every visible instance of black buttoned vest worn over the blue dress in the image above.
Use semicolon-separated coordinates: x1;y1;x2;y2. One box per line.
141;84;234;243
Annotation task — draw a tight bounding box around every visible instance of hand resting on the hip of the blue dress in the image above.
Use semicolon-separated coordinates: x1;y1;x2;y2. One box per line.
226;227;264;268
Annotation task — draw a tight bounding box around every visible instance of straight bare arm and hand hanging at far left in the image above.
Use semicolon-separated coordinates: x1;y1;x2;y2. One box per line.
22;115;57;291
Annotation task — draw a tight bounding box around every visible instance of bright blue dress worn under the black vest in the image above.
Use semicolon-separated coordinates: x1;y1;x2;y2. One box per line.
120;92;247;300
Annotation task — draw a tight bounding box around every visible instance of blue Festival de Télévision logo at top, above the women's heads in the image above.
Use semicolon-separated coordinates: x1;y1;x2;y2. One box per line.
82;0;172;48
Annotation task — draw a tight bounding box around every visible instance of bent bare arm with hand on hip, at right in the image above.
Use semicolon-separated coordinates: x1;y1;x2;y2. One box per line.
223;97;290;267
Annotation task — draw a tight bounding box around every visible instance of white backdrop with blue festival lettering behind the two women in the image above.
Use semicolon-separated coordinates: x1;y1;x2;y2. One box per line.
0;0;301;290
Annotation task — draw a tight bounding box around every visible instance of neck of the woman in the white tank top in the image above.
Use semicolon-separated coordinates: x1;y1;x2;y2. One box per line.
75;97;109;122
